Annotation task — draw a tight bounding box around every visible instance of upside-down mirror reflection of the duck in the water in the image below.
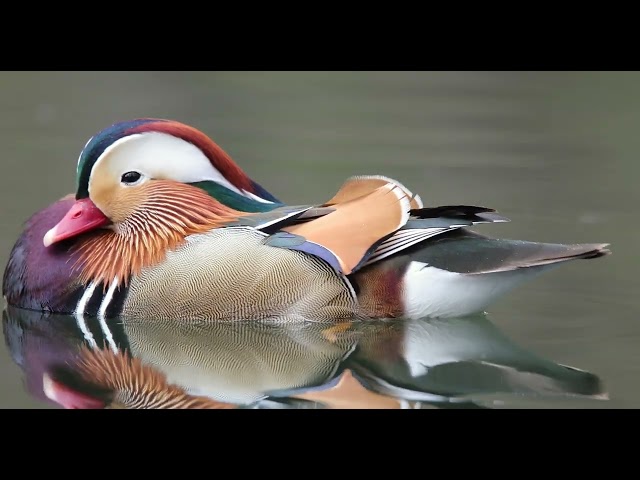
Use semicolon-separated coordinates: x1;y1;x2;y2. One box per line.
3;306;606;409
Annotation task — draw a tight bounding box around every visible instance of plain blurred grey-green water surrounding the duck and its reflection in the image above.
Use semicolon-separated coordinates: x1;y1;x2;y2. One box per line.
0;72;640;407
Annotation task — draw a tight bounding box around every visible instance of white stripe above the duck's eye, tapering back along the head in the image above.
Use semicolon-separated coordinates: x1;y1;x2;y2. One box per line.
89;132;244;195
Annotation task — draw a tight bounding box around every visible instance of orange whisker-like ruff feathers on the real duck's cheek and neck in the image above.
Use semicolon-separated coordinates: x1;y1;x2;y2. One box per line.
74;180;241;289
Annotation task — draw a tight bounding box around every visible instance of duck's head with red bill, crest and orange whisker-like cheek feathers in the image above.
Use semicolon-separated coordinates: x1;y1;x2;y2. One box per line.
43;119;280;283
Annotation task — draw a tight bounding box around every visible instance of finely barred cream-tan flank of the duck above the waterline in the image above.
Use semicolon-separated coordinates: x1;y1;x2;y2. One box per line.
122;227;358;320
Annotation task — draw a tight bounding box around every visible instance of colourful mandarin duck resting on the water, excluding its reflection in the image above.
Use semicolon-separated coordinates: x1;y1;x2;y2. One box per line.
3;118;611;322
